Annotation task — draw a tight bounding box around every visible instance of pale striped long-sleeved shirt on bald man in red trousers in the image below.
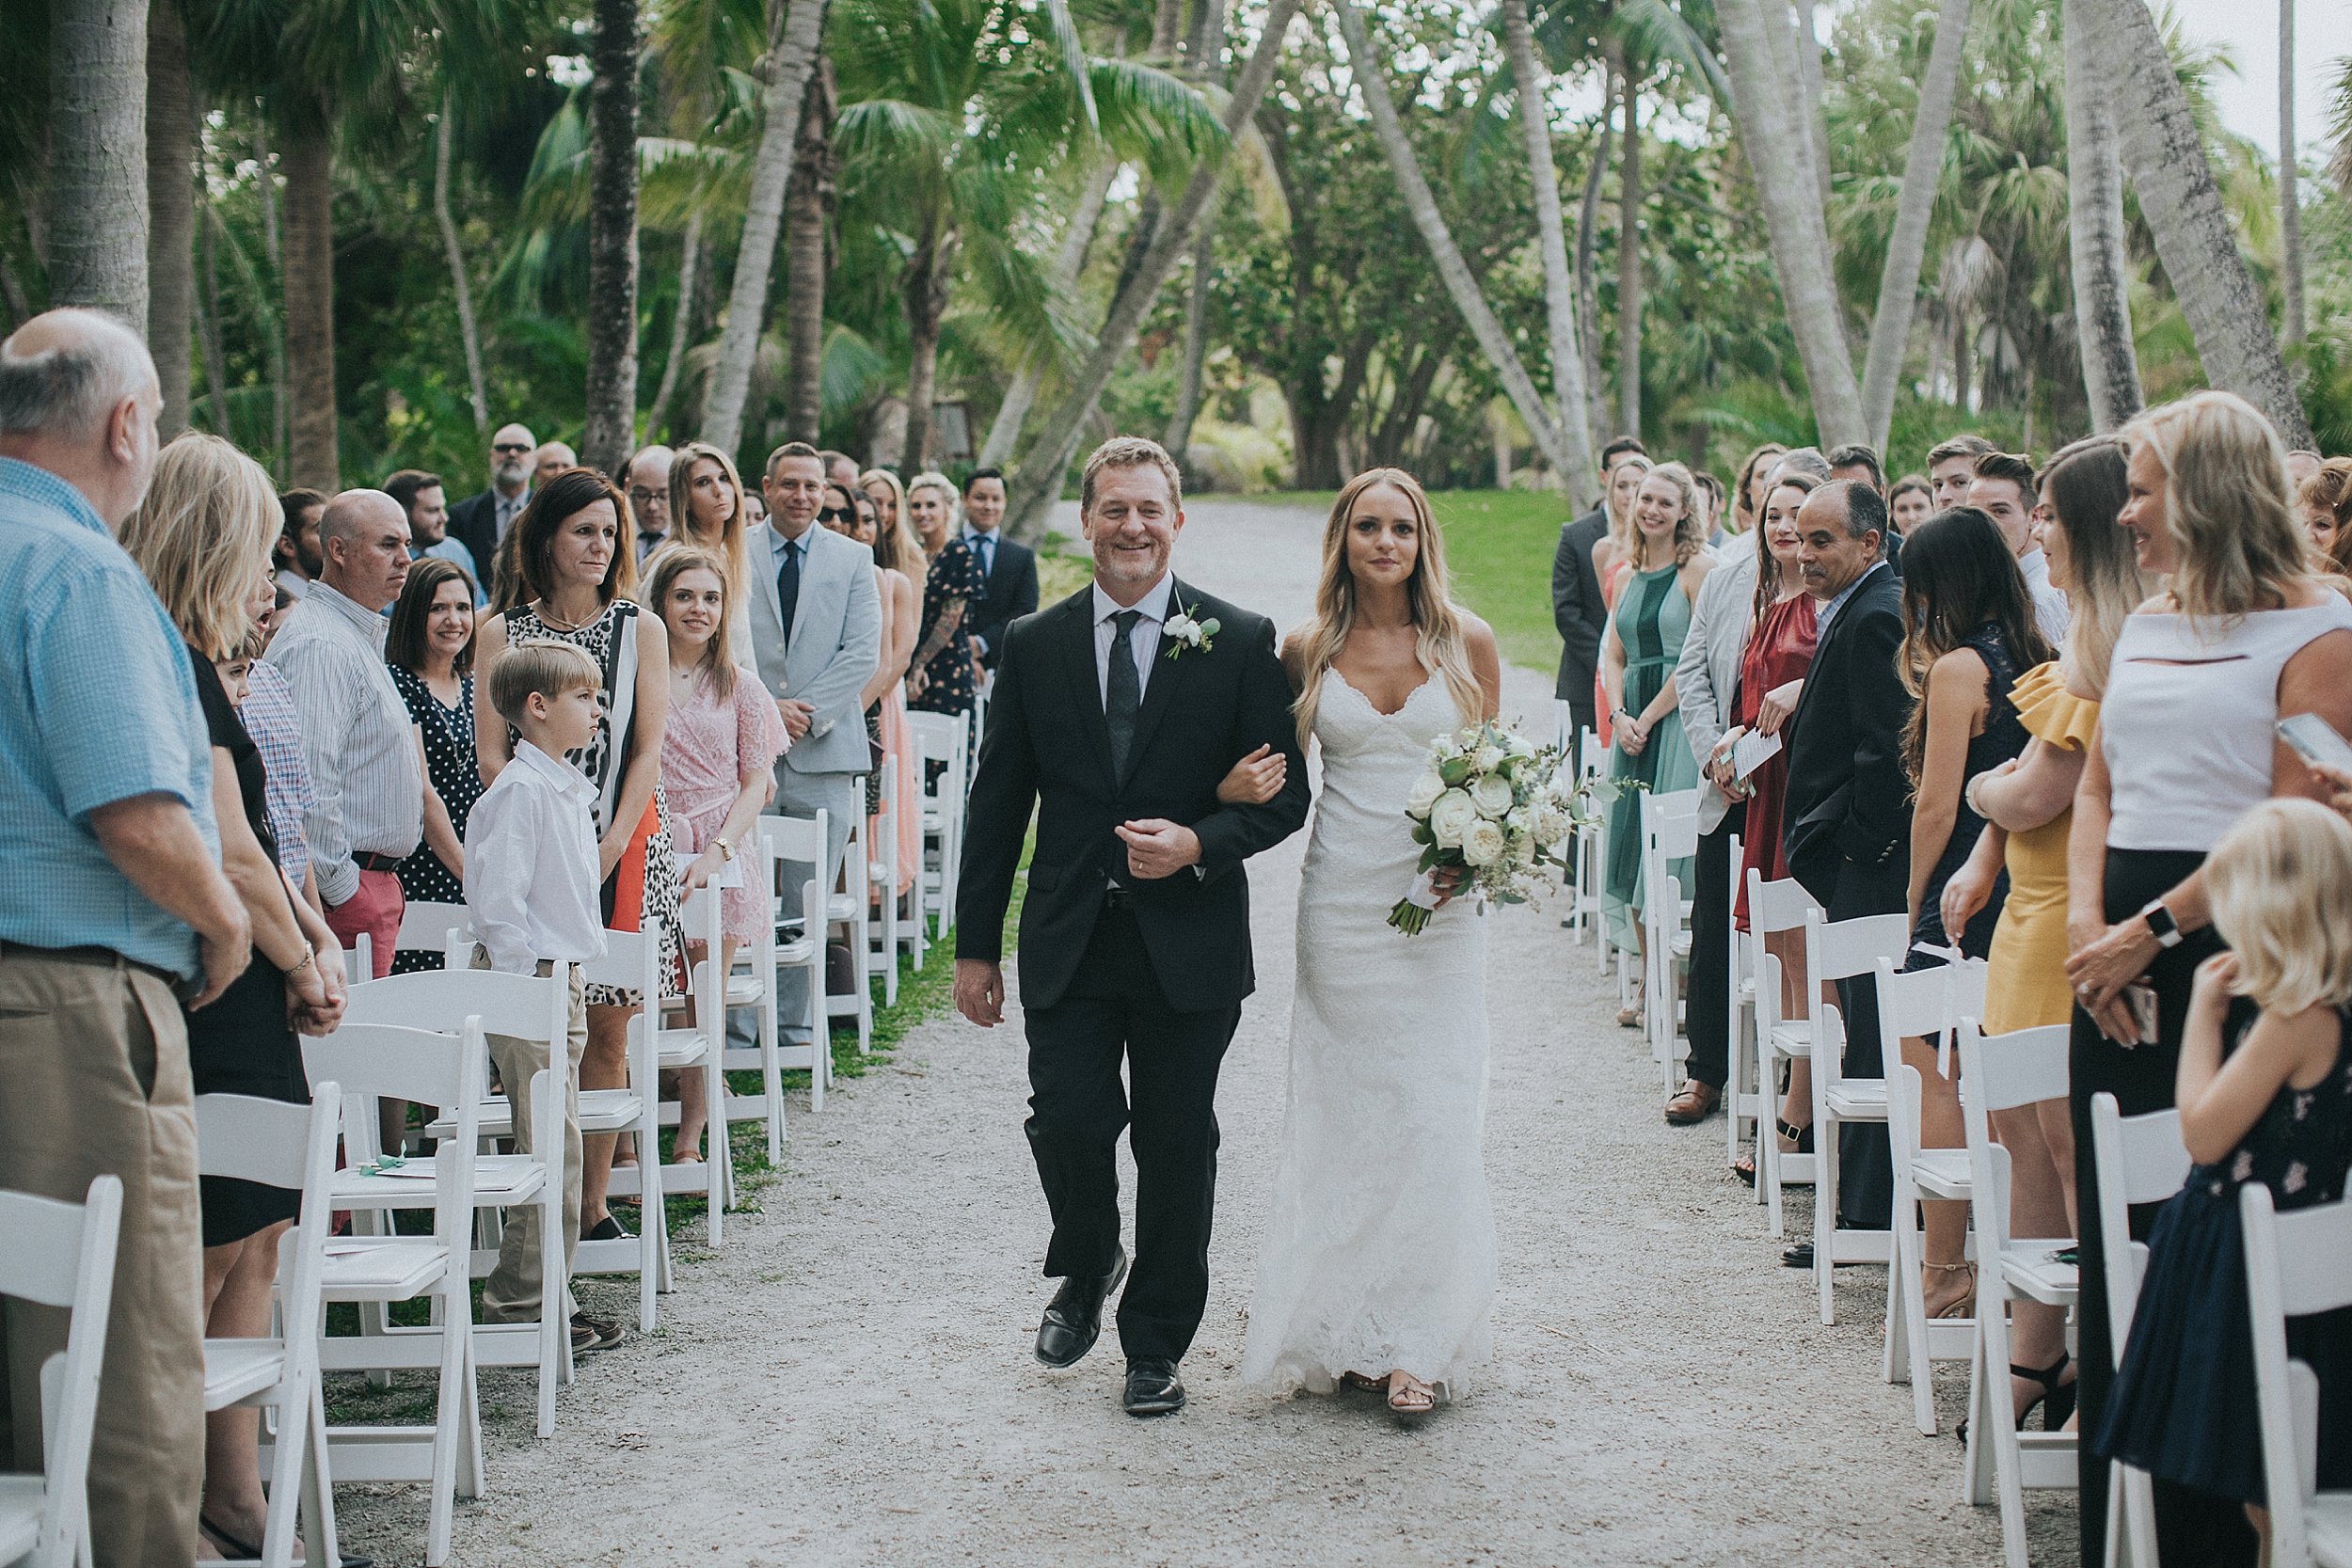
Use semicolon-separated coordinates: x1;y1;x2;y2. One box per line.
266;580;426;905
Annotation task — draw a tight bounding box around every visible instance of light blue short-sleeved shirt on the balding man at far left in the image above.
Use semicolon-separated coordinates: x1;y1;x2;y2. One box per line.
0;458;219;980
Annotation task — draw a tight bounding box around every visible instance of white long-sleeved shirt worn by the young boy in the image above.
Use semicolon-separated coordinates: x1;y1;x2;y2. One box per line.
466;740;605;975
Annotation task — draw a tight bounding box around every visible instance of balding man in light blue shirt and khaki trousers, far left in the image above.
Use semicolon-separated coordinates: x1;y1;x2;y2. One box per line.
0;310;252;1563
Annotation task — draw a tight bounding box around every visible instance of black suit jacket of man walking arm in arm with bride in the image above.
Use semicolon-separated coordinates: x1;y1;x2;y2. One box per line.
955;583;1308;1011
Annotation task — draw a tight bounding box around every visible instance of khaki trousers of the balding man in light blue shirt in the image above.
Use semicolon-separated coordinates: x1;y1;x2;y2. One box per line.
0;945;205;1568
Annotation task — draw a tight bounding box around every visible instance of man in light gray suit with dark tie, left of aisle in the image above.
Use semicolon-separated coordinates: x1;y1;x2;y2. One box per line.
748;442;882;1041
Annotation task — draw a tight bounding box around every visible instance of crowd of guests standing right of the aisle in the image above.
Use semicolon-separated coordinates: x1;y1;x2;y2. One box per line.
1552;392;2352;1566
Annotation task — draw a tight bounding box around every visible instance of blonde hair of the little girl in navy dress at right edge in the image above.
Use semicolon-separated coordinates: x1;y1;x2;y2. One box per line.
2206;800;2352;1013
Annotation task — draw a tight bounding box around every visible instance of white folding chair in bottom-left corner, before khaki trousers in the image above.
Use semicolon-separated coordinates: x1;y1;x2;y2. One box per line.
0;1176;122;1568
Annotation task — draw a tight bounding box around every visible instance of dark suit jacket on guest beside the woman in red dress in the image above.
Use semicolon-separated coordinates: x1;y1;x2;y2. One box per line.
1783;566;1913;886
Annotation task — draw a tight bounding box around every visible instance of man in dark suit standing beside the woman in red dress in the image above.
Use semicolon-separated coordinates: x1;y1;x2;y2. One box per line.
1783;480;1913;1267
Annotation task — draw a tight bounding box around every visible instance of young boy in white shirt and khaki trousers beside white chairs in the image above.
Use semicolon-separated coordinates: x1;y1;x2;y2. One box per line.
466;641;621;1352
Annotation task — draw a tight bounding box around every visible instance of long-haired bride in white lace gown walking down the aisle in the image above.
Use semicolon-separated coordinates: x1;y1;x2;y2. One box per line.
1242;467;1503;1416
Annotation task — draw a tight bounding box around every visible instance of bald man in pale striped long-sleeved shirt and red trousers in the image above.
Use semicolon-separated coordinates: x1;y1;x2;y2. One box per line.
268;491;425;980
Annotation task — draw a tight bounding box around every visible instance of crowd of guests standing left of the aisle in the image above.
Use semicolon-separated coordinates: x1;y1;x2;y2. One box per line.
0;310;1038;1563
